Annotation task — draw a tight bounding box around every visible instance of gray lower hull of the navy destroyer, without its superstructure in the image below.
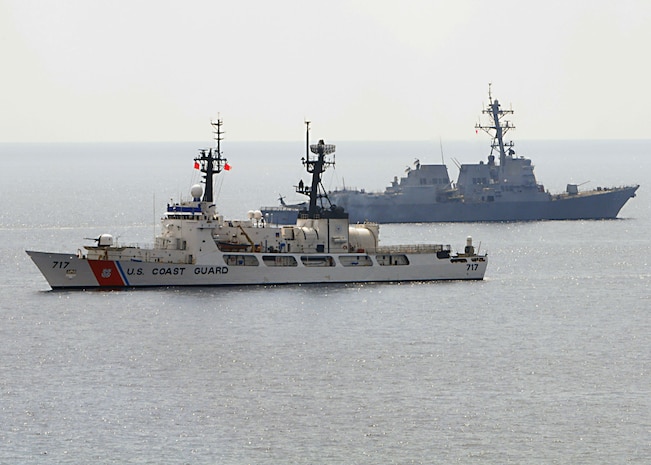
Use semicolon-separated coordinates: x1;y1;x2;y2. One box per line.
328;186;637;223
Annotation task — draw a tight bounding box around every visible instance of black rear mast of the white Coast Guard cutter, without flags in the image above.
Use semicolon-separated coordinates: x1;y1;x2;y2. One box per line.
296;121;335;219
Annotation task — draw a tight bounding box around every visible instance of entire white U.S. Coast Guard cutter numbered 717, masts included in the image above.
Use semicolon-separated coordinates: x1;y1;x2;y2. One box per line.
27;120;488;289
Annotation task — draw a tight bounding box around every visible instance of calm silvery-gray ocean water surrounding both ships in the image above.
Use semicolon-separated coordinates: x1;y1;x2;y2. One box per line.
0;139;651;464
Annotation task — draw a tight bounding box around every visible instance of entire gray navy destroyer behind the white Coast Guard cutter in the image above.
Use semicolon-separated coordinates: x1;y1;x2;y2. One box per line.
262;87;639;223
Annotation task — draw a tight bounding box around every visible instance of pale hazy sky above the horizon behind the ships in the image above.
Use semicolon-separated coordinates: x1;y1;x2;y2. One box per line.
0;0;651;142
